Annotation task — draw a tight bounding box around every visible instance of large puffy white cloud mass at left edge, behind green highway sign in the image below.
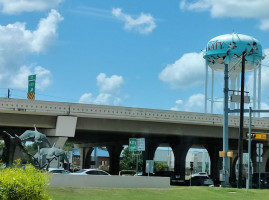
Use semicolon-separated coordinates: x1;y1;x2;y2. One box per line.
0;10;63;89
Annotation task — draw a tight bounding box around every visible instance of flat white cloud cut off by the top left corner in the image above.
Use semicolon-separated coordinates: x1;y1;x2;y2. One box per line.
0;0;62;14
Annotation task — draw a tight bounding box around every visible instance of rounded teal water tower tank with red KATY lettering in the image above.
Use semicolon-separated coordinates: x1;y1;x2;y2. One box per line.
204;33;263;73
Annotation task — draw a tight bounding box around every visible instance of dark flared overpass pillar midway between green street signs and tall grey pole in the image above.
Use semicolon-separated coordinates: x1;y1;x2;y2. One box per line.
170;139;192;180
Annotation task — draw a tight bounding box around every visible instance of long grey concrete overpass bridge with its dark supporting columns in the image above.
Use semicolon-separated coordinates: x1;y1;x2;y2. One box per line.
0;98;269;180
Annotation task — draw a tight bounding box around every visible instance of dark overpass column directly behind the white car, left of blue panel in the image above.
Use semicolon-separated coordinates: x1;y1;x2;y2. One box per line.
74;144;93;169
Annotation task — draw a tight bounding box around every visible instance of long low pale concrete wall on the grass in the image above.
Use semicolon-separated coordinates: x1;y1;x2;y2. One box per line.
50;174;170;188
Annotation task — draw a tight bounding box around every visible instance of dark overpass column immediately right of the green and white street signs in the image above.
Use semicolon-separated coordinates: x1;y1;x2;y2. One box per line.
142;138;159;175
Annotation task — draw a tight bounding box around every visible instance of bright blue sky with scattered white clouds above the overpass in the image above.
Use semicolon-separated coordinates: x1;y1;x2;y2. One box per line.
0;0;269;112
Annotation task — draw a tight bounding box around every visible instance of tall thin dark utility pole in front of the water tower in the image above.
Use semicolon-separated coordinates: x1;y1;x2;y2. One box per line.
237;50;246;188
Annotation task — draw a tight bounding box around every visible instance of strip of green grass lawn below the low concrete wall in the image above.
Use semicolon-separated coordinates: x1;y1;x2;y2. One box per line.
48;187;269;200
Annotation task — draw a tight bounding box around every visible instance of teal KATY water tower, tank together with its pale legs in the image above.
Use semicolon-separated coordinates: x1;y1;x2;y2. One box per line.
204;33;263;113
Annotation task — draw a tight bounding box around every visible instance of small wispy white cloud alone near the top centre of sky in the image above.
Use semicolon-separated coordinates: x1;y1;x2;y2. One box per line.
112;8;156;34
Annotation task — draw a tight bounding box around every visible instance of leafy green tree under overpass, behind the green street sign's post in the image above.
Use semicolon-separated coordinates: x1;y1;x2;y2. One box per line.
120;147;143;171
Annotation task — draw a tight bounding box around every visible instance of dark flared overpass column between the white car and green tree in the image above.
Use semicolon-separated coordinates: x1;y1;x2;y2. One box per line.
106;145;123;175
